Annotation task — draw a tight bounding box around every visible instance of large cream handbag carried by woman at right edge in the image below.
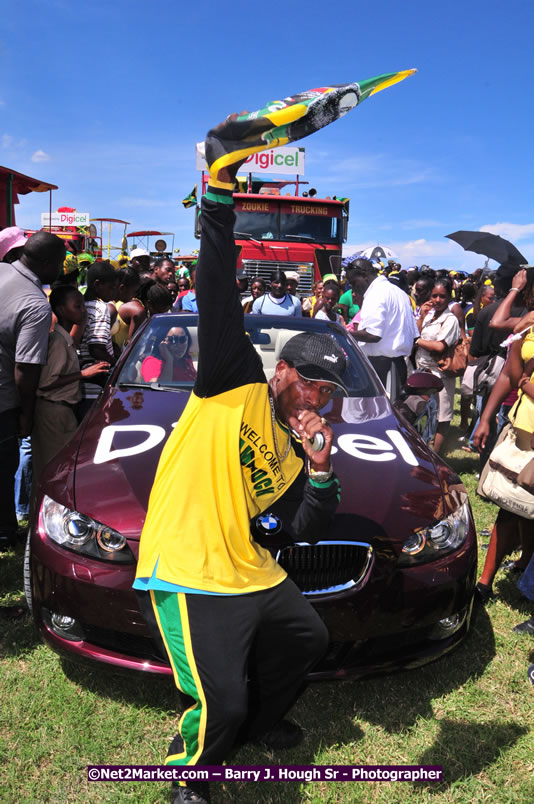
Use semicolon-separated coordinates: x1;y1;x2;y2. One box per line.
477;424;534;519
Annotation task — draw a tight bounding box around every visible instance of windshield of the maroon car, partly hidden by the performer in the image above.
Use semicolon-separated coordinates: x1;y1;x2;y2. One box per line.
116;313;384;397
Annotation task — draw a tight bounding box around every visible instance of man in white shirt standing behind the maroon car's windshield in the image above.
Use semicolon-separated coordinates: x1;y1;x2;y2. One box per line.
347;259;419;395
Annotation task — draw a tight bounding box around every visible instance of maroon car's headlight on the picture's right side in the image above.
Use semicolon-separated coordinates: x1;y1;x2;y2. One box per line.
398;503;471;567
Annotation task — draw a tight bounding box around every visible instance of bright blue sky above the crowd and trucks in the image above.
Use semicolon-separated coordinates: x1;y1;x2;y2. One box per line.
0;0;534;270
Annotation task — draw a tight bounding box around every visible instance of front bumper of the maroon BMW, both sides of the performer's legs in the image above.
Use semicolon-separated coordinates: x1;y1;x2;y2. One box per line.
31;520;476;679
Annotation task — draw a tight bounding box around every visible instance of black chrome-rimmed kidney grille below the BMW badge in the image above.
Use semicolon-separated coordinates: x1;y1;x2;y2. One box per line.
276;542;373;595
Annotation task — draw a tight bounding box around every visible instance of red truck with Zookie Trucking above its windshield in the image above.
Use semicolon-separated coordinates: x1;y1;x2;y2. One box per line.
195;191;349;295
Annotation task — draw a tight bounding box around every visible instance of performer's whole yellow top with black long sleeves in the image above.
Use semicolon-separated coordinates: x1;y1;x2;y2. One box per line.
134;188;339;594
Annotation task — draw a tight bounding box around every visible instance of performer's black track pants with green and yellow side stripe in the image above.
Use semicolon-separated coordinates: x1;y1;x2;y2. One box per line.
144;578;328;765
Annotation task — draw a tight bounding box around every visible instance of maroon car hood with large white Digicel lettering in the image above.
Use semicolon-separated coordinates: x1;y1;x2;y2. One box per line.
70;388;467;542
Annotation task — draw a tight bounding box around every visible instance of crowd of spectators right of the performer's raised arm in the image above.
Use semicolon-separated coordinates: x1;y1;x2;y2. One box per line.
198;257;534;688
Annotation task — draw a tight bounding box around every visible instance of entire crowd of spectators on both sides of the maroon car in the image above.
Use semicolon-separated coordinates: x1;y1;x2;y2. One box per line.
0;206;534;796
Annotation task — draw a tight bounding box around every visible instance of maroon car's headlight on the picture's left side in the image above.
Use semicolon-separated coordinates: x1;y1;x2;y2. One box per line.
39;494;135;564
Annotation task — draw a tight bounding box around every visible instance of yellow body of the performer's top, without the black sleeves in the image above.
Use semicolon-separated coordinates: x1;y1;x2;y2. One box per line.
136;383;303;594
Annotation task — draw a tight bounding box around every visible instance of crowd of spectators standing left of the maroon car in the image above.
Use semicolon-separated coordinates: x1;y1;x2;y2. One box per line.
0;227;178;556
